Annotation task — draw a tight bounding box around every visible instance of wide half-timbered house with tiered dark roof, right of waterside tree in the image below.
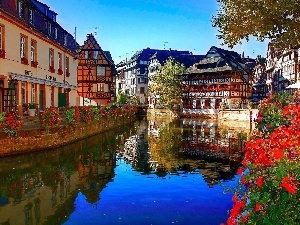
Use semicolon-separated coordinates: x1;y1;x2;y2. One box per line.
182;46;251;115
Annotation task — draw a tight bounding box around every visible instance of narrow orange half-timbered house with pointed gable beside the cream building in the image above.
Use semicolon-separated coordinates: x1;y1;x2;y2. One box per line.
77;34;116;106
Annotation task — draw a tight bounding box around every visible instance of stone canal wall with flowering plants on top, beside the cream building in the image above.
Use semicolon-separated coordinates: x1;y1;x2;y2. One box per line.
0;106;135;156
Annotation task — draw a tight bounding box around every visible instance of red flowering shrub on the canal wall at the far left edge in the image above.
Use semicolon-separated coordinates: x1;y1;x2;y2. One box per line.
0;112;22;138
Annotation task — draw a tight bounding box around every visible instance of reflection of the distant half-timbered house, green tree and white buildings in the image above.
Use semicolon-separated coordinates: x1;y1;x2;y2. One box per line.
118;119;243;186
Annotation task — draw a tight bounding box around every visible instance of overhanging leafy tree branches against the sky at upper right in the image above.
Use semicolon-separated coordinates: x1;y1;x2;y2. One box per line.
212;0;300;47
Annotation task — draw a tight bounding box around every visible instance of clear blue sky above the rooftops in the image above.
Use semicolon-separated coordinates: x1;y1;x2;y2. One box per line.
40;0;267;63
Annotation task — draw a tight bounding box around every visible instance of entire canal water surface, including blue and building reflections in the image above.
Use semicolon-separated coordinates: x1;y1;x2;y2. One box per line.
0;118;242;225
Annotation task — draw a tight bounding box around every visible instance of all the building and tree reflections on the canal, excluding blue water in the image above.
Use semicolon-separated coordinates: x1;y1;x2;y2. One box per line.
0;119;246;225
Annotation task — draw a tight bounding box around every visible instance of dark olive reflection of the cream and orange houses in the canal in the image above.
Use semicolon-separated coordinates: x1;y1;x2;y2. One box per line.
0;127;127;225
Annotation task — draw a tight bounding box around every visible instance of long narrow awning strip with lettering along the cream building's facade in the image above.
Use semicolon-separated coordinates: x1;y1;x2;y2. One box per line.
9;73;78;90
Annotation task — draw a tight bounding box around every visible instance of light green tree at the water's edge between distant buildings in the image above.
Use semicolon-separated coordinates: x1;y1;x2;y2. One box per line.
148;57;186;109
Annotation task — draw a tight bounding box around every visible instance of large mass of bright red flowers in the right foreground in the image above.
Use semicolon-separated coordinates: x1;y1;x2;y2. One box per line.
227;92;300;224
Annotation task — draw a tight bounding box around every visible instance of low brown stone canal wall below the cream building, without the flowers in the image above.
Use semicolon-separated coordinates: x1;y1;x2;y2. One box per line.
0;115;136;157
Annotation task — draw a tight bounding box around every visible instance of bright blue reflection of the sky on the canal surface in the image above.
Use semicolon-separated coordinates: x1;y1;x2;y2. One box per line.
65;160;237;225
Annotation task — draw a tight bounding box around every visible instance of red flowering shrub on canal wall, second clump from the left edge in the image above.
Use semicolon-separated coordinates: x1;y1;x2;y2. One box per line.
41;107;61;132
